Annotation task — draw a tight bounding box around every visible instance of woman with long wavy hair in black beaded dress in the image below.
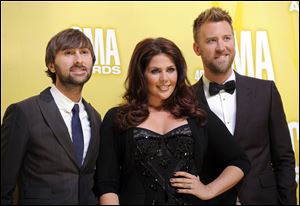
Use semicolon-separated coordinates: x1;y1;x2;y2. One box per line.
96;38;250;205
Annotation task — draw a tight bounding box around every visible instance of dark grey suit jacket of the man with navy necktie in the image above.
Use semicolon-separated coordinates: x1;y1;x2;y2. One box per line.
1;88;101;205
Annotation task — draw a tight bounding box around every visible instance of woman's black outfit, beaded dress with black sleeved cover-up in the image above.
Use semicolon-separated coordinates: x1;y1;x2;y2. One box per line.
95;108;250;205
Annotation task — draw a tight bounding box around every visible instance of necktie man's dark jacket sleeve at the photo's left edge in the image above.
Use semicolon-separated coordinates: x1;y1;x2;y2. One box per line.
1;104;29;205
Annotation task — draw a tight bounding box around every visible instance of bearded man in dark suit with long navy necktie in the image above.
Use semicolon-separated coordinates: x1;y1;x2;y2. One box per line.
1;29;101;205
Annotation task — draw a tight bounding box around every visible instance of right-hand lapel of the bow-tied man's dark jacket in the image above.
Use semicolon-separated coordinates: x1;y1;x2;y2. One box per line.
234;73;254;138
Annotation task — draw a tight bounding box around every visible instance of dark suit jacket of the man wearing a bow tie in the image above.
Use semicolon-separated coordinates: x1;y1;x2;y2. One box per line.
193;73;296;204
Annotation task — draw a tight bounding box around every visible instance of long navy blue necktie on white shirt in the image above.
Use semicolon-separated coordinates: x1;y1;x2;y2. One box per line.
71;104;83;166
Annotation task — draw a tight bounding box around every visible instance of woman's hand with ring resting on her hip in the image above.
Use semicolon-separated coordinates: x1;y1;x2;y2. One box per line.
170;171;214;200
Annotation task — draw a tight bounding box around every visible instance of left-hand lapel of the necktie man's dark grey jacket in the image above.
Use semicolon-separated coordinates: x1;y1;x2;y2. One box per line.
38;87;78;166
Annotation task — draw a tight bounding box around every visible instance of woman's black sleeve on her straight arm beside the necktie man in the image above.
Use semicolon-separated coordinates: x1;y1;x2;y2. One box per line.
95;108;120;197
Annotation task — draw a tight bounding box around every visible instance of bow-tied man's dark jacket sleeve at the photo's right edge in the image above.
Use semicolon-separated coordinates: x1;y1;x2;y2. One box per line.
269;82;297;205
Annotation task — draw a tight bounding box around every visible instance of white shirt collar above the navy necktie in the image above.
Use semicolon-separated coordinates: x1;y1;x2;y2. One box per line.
50;84;83;113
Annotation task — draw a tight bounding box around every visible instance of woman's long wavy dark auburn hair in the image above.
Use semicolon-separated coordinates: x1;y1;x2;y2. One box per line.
116;38;206;129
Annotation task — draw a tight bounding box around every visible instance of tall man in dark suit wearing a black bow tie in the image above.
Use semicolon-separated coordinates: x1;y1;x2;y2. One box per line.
193;8;296;205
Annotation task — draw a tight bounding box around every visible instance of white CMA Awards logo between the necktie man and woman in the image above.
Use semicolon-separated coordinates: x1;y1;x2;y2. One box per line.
72;26;121;74
